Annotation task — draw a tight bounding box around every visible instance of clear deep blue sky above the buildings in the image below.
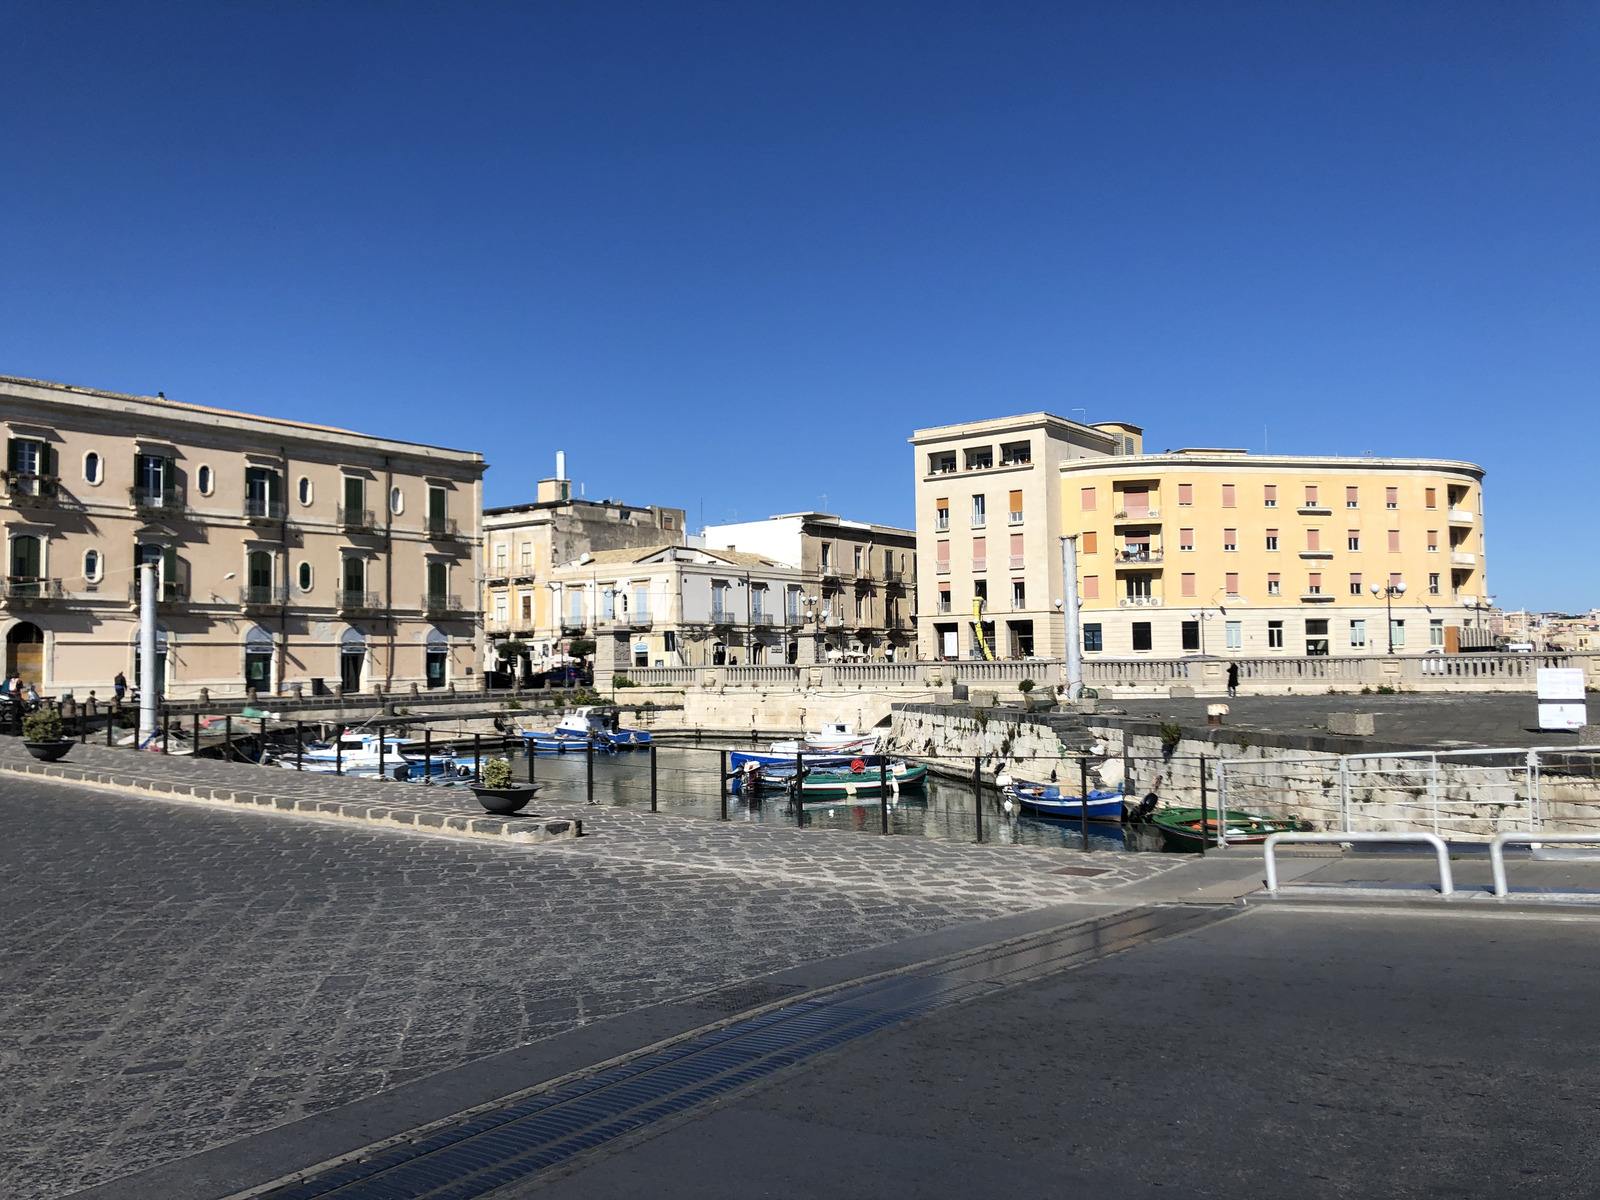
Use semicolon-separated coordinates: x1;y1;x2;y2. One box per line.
0;0;1600;610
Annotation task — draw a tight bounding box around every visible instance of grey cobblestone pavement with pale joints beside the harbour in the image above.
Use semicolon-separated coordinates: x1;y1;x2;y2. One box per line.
0;747;1176;1200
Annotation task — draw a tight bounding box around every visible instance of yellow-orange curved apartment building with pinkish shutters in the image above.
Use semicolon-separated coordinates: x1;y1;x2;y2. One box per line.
1058;450;1493;658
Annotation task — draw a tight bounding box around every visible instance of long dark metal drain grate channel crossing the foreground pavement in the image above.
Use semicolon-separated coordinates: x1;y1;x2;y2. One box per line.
262;906;1237;1200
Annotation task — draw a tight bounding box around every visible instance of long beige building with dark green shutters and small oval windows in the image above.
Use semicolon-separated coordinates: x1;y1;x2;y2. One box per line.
0;378;485;699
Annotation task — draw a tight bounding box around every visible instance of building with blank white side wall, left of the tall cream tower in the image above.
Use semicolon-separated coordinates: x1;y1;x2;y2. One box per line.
701;512;917;662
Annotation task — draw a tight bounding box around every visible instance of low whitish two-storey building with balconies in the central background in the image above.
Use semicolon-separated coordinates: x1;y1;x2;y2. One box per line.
550;546;803;675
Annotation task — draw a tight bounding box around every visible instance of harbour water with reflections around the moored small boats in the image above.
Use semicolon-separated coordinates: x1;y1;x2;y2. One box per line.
514;746;1158;851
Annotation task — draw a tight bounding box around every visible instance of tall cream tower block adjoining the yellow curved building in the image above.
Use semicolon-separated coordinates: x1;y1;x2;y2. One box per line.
910;413;1144;659
